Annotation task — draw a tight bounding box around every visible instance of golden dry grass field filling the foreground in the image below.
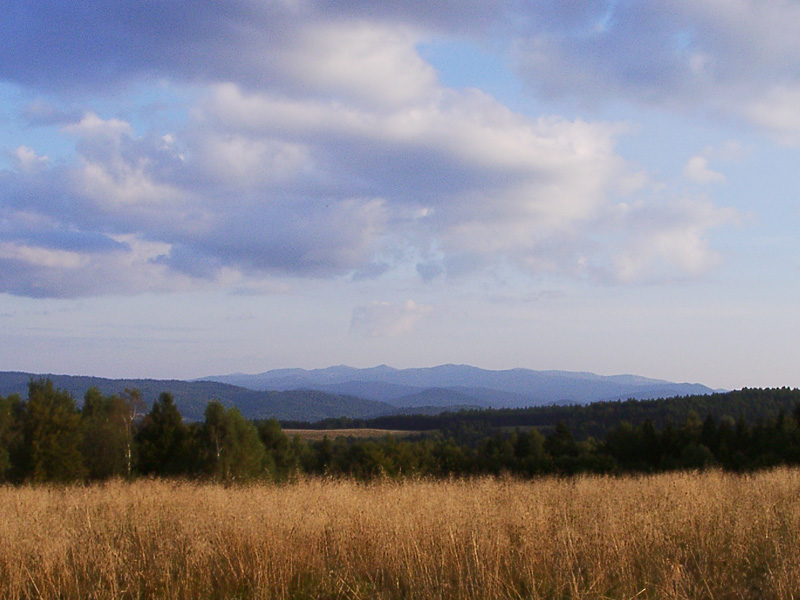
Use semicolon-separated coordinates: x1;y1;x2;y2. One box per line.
0;469;800;600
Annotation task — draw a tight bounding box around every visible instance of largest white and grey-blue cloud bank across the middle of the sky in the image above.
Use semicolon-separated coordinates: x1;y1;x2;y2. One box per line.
0;67;736;293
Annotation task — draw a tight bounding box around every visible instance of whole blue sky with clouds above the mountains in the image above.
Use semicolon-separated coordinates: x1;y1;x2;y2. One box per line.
0;0;800;389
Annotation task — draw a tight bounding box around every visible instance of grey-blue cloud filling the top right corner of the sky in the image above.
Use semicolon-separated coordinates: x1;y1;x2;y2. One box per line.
515;0;800;135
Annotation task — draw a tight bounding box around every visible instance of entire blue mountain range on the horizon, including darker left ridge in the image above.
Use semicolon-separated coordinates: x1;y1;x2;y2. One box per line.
0;365;715;421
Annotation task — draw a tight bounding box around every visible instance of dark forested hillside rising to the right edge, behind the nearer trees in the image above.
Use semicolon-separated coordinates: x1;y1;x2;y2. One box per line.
284;387;800;439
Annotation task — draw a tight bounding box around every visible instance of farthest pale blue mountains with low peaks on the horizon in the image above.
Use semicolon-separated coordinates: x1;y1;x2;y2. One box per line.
203;365;715;408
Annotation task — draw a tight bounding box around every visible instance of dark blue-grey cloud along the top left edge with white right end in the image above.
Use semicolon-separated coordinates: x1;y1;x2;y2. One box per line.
0;0;488;101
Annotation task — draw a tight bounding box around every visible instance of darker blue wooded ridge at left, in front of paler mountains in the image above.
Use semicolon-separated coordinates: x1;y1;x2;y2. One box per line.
0;371;396;421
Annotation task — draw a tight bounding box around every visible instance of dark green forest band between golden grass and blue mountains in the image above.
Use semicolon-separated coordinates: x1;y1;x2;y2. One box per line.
0;379;800;483
